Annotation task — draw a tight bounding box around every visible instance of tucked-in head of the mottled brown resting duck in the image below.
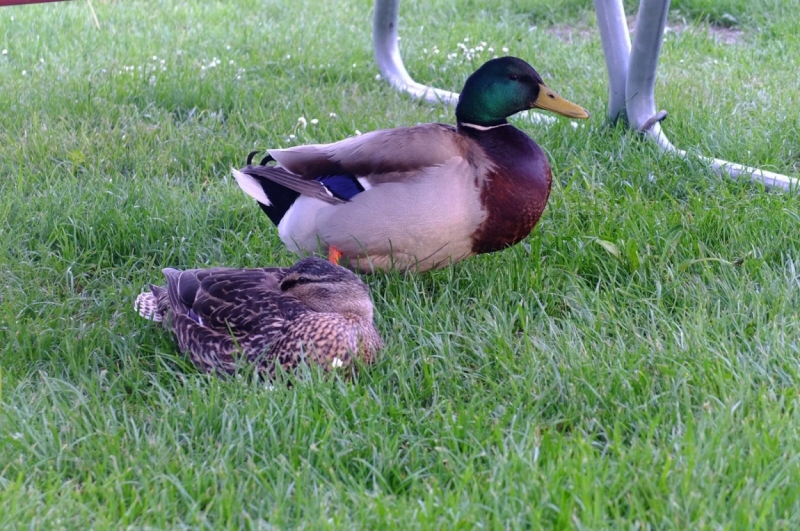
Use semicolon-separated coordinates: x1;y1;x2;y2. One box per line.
279;257;372;321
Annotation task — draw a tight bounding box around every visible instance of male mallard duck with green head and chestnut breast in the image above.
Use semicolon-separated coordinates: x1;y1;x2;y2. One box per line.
233;57;589;271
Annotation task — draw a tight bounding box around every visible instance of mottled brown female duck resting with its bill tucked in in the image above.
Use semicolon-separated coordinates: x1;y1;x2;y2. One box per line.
134;257;382;377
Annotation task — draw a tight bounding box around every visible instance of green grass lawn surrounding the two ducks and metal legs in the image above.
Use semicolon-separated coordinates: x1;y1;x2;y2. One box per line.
0;0;800;529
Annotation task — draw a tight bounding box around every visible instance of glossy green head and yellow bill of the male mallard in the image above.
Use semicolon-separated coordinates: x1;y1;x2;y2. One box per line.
456;56;589;127
